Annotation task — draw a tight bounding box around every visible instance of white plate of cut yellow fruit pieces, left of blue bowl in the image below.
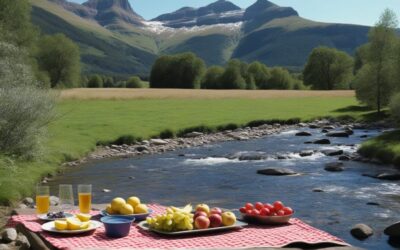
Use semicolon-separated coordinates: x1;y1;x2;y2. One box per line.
42;214;102;234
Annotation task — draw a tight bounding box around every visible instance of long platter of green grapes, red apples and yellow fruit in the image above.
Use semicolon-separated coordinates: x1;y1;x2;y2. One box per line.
138;204;247;236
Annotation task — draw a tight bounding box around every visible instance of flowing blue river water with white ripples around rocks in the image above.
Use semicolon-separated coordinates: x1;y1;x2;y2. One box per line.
51;129;400;249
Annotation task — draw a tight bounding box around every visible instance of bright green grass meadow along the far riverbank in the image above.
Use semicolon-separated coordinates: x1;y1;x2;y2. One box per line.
0;90;376;204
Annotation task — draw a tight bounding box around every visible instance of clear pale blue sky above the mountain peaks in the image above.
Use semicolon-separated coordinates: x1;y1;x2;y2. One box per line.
70;0;400;25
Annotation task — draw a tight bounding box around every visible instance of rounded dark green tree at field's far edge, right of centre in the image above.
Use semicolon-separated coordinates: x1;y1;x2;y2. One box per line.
303;47;353;90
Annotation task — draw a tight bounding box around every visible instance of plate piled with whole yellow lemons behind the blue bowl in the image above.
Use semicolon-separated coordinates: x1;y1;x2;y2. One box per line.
101;196;153;221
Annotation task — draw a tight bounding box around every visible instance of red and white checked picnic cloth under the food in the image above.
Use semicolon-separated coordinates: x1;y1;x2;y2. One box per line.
8;204;348;249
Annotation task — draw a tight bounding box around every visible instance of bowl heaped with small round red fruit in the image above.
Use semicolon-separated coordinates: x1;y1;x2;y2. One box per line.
239;201;294;225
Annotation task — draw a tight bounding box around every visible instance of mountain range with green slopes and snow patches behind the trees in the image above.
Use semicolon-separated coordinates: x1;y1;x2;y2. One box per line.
30;0;370;76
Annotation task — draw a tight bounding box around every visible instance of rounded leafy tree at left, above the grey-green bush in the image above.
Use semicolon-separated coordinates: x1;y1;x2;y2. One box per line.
37;34;81;87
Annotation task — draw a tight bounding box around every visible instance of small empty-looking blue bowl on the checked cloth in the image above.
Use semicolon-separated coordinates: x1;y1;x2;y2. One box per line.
101;216;135;238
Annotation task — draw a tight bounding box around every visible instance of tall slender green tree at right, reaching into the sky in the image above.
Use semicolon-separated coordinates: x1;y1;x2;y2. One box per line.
355;9;398;113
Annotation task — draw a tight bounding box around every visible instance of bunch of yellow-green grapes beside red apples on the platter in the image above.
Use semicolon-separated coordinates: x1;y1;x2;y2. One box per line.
147;207;193;232
